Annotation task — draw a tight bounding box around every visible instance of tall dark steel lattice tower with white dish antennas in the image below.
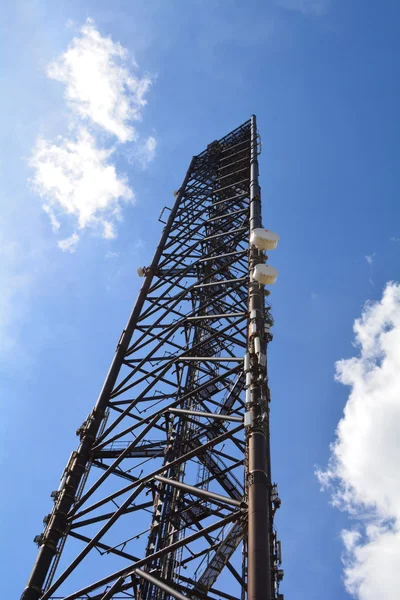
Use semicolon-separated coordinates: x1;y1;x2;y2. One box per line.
22;116;283;600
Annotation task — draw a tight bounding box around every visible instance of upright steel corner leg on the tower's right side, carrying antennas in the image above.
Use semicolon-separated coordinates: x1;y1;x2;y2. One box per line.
246;115;272;600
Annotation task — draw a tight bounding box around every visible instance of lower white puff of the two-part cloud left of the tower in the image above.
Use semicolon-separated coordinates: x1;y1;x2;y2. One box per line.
30;128;134;238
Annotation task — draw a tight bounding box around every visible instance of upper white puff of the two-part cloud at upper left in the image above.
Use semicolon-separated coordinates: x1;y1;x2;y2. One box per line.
47;19;151;142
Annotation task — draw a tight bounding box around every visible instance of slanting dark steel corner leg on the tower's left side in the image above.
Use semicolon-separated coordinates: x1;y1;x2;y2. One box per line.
21;158;195;600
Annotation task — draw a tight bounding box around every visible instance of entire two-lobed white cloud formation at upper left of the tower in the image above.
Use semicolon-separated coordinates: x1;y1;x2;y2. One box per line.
30;19;157;252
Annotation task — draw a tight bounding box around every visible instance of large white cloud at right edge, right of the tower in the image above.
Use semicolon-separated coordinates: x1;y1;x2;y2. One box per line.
318;283;400;600
